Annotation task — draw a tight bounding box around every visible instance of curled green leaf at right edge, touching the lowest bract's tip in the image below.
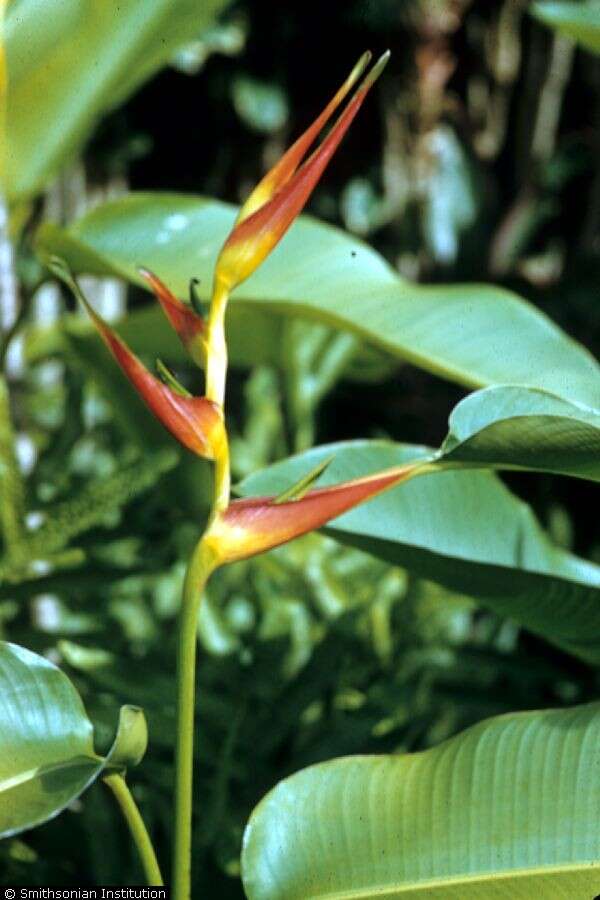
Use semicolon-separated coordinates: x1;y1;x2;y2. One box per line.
439;387;600;481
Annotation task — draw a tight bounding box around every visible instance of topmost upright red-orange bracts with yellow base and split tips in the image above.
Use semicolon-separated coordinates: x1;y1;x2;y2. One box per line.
215;51;390;291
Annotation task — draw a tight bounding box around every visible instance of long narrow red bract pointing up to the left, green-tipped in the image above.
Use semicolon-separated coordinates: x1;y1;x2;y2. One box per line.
49;259;224;459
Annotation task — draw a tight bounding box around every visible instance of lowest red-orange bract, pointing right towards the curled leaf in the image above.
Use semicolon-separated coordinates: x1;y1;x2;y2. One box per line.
205;460;425;565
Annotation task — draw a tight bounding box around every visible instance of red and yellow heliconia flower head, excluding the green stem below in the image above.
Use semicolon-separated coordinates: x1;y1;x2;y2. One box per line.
51;52;418;568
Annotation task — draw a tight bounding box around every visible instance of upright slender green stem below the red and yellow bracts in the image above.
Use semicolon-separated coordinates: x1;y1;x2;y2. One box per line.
172;539;215;900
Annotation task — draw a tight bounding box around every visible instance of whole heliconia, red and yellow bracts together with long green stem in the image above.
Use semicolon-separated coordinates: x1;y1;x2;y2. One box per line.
54;49;396;900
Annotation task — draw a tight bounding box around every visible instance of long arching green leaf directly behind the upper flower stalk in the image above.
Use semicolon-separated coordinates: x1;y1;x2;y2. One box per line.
38;194;600;407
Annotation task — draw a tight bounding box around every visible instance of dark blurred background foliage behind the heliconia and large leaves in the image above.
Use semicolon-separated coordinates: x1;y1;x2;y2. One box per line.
0;0;600;897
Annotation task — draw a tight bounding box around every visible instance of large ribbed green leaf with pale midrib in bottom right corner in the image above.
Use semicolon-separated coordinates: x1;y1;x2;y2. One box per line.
242;703;600;900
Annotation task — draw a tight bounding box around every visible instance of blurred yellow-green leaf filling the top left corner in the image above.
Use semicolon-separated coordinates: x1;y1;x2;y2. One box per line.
6;0;230;200
